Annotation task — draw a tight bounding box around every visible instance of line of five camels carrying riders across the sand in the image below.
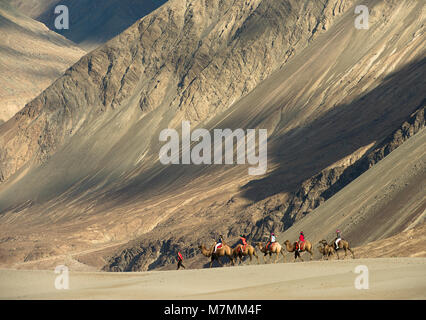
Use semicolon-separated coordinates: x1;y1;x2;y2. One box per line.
199;230;355;268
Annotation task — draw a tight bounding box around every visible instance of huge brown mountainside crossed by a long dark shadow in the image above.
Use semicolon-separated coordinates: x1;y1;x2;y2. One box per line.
0;0;426;271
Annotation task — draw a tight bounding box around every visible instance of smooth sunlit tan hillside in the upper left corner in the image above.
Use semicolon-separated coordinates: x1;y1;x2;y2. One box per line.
0;0;85;122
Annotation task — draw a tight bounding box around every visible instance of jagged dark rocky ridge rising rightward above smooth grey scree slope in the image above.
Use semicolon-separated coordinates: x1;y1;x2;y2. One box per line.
251;105;425;238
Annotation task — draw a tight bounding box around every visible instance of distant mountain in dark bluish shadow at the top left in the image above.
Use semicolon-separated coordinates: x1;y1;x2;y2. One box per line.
10;0;166;51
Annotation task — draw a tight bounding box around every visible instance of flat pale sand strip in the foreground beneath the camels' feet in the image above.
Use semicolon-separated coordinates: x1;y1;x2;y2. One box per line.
0;258;426;300
